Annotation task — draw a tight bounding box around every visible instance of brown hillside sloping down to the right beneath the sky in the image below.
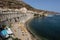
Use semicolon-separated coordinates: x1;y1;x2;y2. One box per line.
0;0;59;13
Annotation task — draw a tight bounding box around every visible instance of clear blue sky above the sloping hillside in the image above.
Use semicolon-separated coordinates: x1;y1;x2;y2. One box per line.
23;0;60;13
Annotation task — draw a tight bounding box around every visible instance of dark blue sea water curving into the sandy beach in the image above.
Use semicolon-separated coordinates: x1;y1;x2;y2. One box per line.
29;15;60;40
